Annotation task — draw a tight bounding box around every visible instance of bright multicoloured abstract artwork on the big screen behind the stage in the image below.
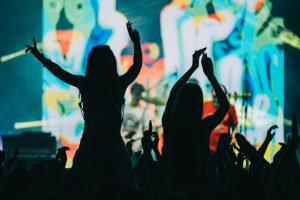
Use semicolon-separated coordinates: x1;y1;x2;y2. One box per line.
43;0;284;166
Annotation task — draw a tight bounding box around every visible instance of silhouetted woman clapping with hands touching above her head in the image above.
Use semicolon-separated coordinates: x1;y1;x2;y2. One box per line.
162;48;229;188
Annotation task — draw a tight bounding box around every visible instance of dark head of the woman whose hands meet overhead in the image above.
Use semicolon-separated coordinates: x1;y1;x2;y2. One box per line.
175;83;203;121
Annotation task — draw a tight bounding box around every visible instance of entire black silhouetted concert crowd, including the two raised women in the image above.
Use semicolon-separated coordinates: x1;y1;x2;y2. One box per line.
0;22;300;200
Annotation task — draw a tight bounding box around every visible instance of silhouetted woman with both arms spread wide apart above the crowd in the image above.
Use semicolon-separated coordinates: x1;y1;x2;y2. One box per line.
26;22;142;188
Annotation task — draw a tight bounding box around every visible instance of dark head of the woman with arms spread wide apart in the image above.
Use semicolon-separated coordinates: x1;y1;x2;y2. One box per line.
85;45;118;81
